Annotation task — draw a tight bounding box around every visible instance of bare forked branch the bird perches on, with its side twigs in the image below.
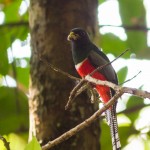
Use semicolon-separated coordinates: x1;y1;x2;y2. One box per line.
41;50;150;150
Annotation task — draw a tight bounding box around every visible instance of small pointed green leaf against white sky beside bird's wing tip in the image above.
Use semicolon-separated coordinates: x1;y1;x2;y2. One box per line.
117;66;128;83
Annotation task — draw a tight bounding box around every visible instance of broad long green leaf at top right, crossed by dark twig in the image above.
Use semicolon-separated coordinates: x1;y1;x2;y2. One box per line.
118;0;150;58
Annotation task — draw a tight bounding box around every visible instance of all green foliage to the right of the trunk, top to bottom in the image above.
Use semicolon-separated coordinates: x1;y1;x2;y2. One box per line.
99;0;150;150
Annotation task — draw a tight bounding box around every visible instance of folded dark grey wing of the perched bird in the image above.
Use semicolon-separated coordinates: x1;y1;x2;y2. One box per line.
88;46;118;84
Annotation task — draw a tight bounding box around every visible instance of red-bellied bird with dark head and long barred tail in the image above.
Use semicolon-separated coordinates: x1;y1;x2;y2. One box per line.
68;28;121;150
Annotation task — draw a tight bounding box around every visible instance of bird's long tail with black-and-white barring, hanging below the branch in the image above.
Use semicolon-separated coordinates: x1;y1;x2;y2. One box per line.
105;105;121;150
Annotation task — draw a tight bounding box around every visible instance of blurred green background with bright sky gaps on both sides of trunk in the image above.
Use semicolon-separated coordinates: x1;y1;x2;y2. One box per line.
0;0;150;150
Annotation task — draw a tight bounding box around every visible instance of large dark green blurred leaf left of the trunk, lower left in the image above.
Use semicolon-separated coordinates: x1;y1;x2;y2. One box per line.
0;87;29;134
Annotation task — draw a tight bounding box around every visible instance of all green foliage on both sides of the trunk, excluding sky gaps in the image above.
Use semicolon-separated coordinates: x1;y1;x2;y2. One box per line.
0;0;150;150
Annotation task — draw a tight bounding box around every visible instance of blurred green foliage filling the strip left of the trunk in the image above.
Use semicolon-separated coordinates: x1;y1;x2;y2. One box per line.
0;0;29;150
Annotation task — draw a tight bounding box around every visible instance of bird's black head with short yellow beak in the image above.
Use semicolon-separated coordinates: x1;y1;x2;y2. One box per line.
67;28;90;43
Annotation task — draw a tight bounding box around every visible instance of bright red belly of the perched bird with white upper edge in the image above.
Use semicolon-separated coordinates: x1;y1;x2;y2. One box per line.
75;59;111;103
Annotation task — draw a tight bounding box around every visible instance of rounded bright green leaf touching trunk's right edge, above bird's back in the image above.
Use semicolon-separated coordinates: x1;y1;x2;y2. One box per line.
100;33;129;58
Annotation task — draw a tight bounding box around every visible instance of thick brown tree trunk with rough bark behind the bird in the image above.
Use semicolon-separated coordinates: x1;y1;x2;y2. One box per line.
29;0;100;150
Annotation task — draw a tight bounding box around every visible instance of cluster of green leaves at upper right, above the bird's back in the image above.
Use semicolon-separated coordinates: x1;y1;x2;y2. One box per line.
100;0;150;59
